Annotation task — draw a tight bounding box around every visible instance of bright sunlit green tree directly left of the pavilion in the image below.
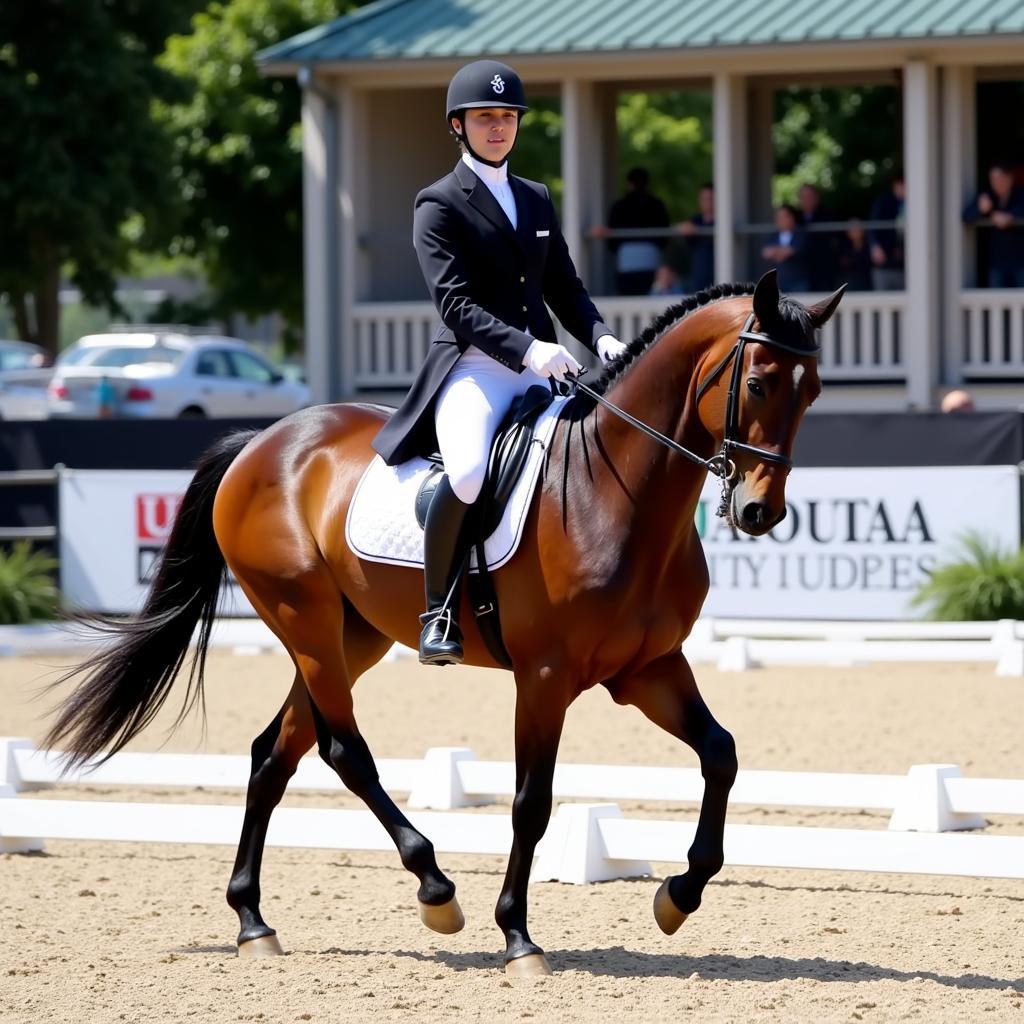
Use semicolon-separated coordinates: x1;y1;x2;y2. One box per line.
157;0;368;346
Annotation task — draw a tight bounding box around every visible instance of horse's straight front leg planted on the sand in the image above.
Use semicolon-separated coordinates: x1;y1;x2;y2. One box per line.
495;668;570;976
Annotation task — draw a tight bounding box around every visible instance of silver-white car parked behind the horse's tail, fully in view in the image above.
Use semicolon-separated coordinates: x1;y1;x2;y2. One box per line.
48;334;310;419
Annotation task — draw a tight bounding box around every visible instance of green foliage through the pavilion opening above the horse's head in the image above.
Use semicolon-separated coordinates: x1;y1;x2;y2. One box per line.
772;85;903;217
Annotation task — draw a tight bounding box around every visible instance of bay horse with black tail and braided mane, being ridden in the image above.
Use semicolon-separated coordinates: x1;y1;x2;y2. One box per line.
46;271;843;975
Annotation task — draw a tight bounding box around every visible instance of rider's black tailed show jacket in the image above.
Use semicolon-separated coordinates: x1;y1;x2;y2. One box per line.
373;161;611;466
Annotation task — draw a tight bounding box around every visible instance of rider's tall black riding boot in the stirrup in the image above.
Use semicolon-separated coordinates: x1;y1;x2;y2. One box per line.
420;474;470;665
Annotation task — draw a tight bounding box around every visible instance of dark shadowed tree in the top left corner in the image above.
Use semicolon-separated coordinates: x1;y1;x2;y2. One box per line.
0;0;199;352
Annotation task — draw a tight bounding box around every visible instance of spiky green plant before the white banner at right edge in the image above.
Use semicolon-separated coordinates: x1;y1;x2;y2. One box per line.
910;531;1024;622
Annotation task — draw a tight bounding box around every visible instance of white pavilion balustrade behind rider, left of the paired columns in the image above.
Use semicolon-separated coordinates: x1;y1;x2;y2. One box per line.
352;292;906;389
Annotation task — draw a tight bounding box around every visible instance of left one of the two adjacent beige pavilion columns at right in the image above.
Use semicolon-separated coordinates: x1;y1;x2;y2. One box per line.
900;60;941;410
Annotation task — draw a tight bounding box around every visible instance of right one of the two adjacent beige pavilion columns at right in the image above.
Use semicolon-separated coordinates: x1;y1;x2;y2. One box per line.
941;67;977;385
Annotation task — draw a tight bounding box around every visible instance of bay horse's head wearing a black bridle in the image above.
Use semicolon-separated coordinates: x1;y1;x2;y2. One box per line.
696;270;846;536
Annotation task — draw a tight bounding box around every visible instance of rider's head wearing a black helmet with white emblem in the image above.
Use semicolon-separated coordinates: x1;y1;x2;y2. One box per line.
445;60;527;167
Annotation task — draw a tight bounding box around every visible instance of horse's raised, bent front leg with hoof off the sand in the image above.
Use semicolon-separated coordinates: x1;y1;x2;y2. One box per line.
605;653;736;935
